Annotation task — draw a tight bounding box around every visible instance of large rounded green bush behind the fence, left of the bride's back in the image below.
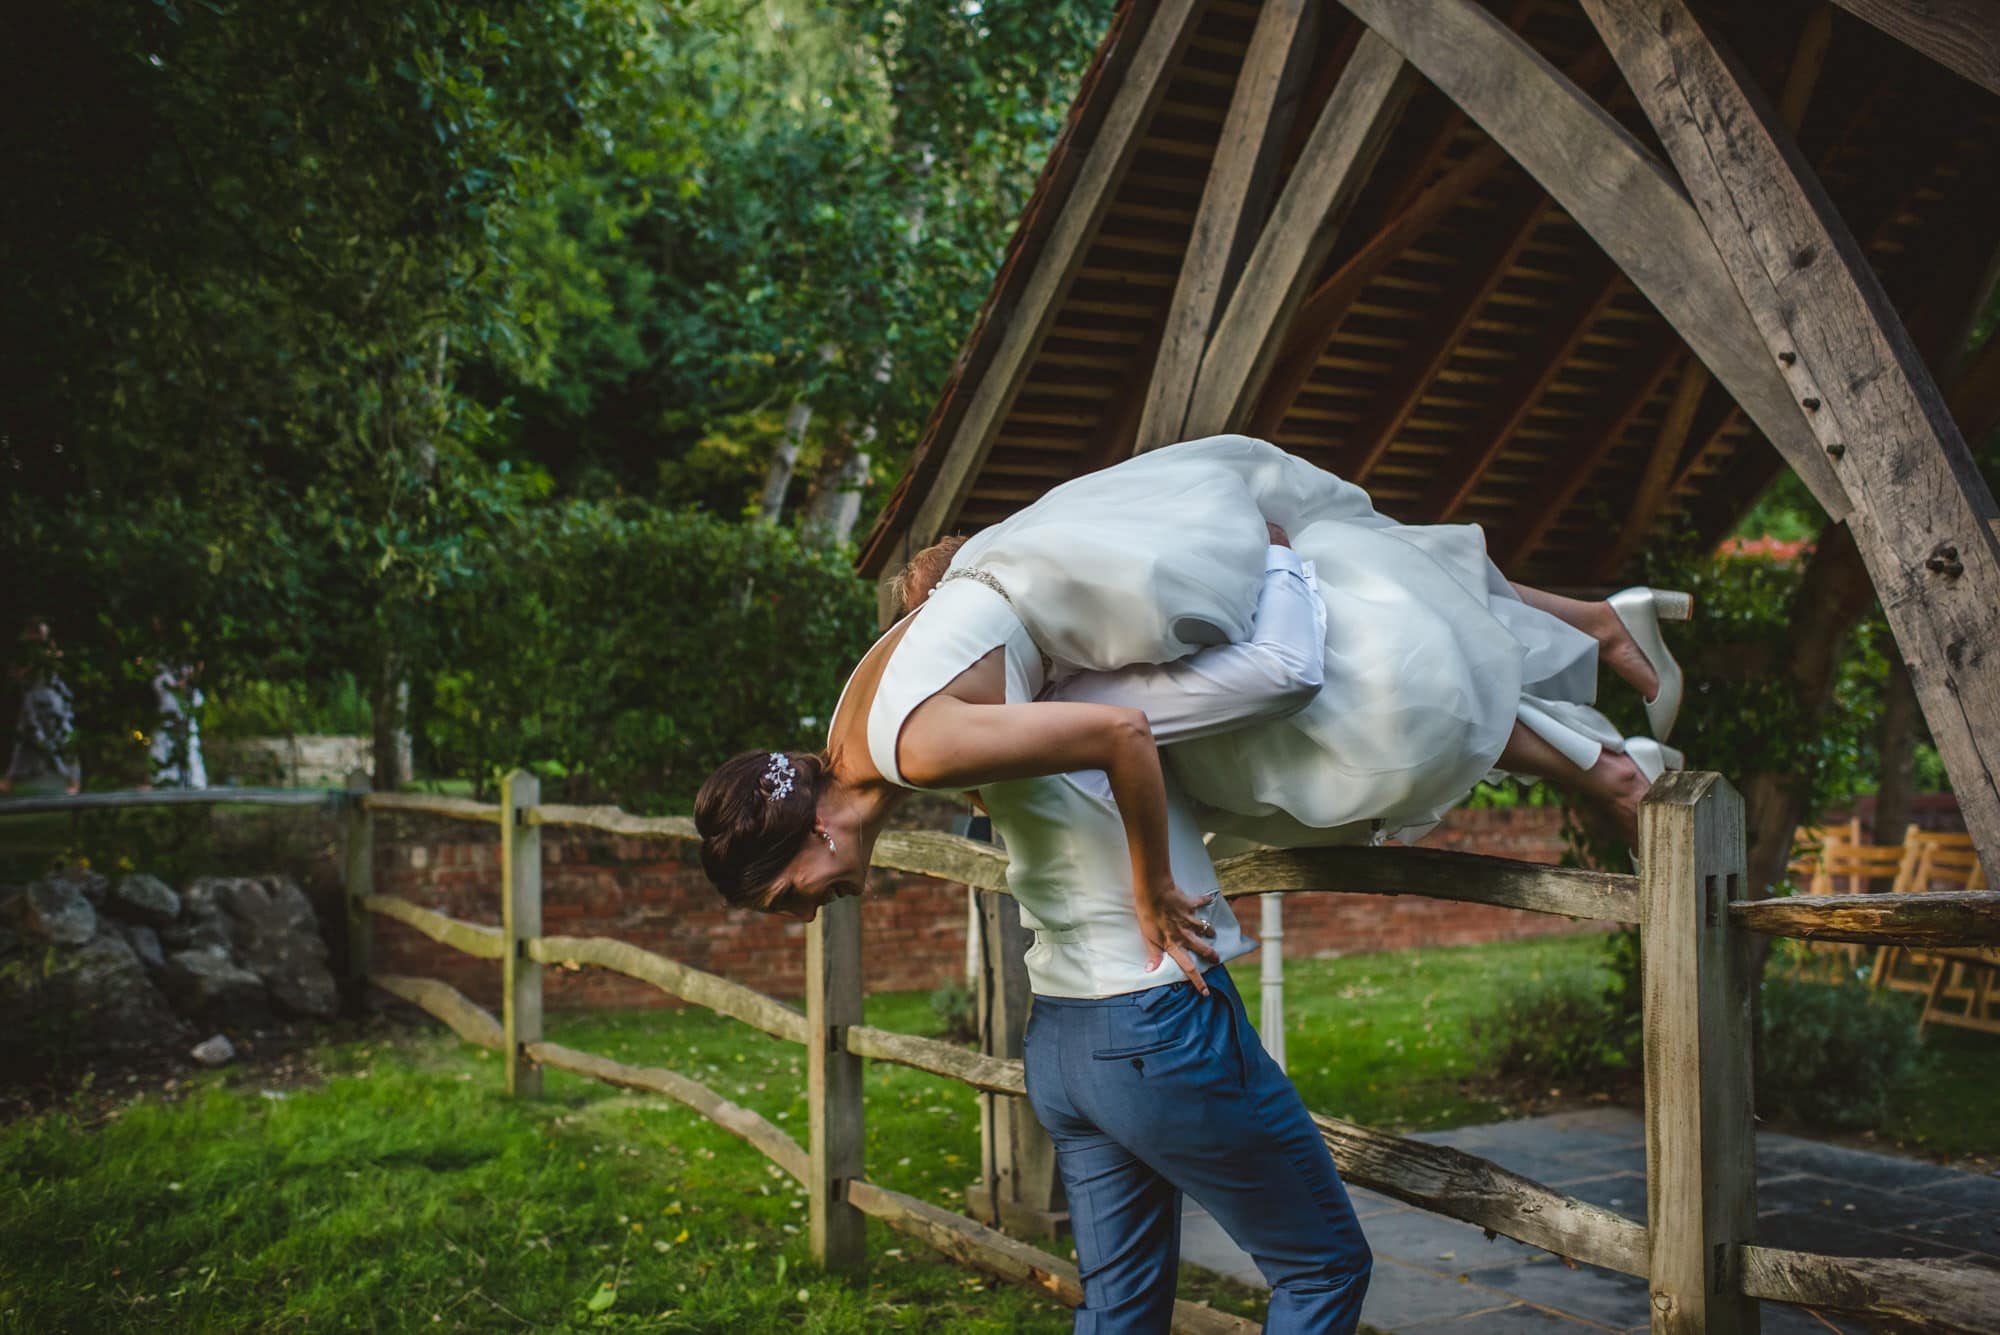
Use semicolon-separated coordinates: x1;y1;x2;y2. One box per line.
416;502;876;809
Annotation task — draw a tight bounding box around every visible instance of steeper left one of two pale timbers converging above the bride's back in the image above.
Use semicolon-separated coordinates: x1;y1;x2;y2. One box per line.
1134;0;1318;452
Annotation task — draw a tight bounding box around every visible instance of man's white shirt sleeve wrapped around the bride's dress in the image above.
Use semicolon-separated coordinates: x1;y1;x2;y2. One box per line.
1042;546;1326;745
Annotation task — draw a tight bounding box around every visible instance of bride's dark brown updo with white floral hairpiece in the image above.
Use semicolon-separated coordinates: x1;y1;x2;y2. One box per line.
694;751;826;907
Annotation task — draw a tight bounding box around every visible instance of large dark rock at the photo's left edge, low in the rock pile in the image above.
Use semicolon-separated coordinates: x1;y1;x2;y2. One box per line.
0;931;186;1059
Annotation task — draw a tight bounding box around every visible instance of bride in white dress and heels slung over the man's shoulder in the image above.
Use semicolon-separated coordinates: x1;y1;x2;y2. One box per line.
696;436;1688;971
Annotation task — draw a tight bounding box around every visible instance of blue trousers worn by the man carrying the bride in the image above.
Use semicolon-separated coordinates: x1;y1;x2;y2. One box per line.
1026;967;1372;1335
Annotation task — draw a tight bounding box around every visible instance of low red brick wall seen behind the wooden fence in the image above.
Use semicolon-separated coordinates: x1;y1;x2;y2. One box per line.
374;809;1592;1007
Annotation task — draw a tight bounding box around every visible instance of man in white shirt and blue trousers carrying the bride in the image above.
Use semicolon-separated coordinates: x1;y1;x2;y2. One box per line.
964;528;1370;1335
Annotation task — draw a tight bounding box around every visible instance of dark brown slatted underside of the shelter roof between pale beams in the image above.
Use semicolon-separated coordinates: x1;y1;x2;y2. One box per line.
860;0;2000;588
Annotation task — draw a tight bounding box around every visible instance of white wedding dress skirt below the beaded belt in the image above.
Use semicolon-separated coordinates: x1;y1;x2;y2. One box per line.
952;436;1622;845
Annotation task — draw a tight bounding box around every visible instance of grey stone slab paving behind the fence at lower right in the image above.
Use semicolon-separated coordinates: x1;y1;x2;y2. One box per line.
1180;1107;2000;1335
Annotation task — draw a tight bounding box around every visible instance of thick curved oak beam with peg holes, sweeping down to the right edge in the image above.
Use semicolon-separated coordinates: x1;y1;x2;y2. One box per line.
1584;0;2000;887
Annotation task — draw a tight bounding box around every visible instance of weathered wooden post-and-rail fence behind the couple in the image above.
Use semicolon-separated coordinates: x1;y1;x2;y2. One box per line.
0;773;2000;1335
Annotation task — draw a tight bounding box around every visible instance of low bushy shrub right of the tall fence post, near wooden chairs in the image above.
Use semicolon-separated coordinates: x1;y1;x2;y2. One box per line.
1756;977;1918;1129
